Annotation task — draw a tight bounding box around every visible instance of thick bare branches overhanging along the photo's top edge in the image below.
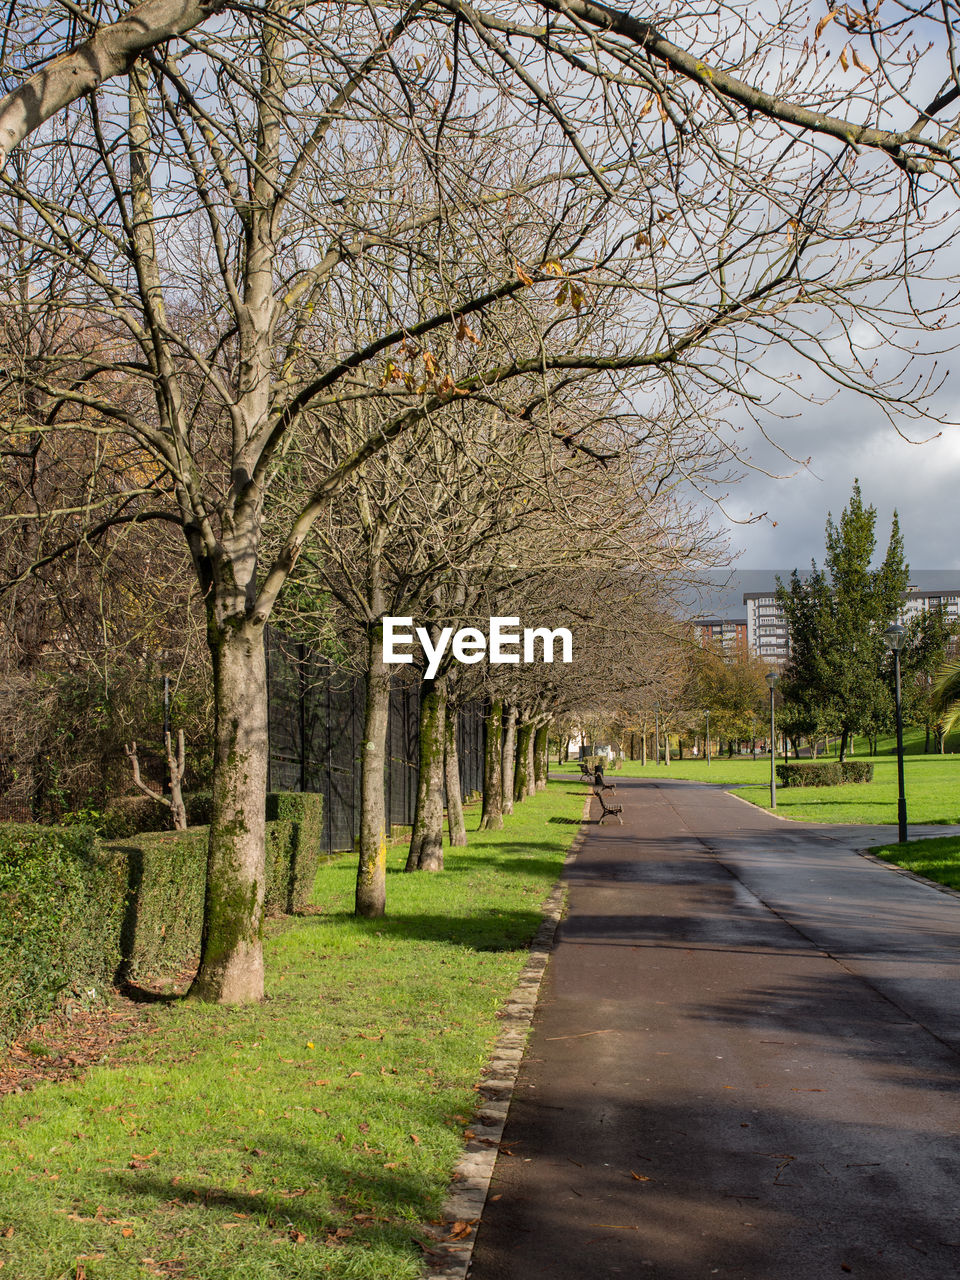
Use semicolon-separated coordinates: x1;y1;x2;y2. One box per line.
0;0;960;180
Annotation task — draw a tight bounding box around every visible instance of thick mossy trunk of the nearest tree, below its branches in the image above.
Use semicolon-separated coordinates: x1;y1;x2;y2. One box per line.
189;620;266;1005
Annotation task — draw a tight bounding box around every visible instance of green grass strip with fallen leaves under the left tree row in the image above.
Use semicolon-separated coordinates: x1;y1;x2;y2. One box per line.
0;782;582;1280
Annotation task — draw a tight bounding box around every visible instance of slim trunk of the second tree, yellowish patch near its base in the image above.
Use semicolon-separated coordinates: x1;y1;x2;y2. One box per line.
355;622;390;918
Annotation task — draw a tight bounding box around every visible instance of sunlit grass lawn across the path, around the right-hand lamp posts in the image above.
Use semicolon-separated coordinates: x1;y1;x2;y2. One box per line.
566;753;960;824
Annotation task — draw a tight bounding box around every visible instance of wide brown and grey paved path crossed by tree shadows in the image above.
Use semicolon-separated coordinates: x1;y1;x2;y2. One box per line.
470;780;960;1280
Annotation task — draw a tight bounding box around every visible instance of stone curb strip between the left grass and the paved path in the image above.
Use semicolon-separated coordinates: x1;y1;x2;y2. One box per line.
424;792;593;1280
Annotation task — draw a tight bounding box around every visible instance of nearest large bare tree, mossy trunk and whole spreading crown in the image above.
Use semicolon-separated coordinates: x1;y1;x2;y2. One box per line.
0;0;952;1001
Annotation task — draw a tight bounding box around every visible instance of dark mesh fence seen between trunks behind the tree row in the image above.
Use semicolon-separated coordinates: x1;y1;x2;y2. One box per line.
266;627;484;852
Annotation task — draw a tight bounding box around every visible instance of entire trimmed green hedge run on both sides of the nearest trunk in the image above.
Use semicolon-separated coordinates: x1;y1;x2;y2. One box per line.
0;792;323;1042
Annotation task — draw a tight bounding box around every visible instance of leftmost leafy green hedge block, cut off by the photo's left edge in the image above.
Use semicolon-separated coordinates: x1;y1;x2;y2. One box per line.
0;823;125;1041
